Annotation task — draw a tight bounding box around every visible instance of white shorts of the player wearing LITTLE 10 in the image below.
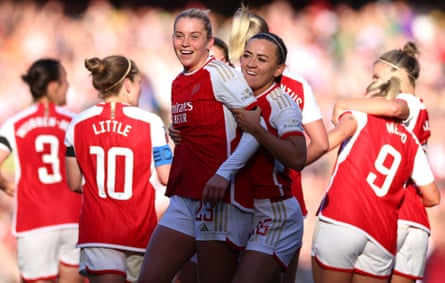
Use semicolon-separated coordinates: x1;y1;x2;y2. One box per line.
79;248;144;282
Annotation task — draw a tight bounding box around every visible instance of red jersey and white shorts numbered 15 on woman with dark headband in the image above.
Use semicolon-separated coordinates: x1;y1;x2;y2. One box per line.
238;84;304;270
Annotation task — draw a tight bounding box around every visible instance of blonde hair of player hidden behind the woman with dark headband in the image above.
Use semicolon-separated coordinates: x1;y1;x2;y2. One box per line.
229;5;269;62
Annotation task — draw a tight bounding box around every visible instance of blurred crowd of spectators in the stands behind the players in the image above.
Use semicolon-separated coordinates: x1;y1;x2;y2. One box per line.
0;0;445;283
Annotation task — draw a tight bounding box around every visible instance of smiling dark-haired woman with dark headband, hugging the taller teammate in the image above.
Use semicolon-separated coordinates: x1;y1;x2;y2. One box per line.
232;32;306;283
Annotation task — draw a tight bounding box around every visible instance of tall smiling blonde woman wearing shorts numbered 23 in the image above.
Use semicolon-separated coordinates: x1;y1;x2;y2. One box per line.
139;8;258;283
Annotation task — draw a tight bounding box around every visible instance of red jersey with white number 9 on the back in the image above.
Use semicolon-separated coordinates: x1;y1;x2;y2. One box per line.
319;111;434;254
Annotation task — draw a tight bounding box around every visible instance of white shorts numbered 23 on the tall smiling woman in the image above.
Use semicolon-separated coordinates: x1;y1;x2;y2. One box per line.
159;196;253;249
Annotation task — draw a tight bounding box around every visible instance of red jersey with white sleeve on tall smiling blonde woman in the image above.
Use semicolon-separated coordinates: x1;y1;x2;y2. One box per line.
166;57;256;207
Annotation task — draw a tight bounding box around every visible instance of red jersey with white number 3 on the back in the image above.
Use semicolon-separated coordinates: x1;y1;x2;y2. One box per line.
0;103;81;236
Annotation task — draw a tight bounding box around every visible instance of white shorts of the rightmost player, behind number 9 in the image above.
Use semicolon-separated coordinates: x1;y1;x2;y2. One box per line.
394;222;429;280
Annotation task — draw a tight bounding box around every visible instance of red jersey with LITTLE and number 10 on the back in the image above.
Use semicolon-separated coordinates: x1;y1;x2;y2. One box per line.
65;103;167;252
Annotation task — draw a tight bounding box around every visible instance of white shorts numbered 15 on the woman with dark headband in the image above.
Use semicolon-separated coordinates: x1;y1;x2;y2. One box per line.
246;197;304;271
